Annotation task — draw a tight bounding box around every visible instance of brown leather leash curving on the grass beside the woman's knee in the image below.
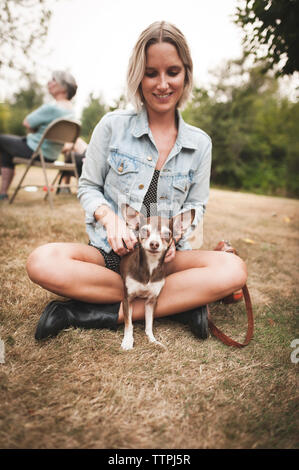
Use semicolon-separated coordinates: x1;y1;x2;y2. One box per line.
208;241;254;348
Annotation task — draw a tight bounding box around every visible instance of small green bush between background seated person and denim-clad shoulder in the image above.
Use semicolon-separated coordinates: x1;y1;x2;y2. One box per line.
81;94;108;142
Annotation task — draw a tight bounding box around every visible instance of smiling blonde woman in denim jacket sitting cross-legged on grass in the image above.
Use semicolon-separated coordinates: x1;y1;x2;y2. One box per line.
27;21;246;339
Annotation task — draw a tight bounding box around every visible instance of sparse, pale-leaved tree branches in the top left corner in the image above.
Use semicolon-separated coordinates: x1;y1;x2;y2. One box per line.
0;0;53;76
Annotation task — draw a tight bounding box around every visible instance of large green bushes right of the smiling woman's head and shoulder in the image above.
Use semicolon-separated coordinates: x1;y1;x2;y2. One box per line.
183;61;299;196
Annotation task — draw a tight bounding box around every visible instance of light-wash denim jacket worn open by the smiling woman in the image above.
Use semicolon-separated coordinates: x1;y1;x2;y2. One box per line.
78;108;212;253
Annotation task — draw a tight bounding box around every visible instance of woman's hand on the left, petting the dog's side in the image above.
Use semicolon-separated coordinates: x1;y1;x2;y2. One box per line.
94;205;137;256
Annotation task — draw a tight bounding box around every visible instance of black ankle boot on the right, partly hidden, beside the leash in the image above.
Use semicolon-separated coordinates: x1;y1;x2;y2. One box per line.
169;305;209;339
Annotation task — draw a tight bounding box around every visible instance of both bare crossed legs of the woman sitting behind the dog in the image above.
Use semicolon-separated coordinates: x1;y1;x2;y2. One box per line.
27;243;247;323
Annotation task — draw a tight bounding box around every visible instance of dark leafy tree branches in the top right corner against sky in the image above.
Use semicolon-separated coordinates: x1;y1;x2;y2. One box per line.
235;0;299;75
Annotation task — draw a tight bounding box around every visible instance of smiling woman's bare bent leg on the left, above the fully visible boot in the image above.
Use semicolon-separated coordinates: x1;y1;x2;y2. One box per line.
26;243;123;303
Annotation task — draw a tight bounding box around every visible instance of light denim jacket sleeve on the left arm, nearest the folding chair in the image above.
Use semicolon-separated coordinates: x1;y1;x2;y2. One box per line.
78;116;111;222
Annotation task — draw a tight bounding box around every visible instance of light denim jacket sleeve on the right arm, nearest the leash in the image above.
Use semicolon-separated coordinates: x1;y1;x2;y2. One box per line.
179;139;212;246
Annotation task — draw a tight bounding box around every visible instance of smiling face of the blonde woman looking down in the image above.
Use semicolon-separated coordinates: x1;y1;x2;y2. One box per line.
141;42;185;114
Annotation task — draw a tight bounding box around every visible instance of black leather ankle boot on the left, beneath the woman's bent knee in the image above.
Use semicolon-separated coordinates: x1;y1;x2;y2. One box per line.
35;300;120;340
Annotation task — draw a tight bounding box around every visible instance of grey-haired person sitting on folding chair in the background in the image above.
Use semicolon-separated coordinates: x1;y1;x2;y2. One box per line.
0;71;77;200
